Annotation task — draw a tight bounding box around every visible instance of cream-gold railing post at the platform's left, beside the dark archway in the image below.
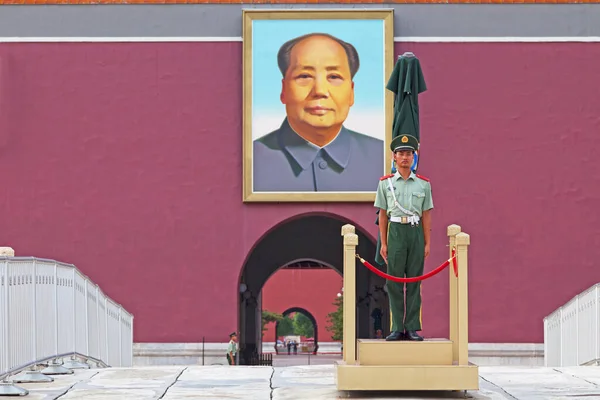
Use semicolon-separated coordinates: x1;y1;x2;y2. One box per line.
342;224;358;364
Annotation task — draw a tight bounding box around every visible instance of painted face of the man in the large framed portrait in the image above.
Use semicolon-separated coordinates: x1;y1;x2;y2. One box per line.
281;36;354;133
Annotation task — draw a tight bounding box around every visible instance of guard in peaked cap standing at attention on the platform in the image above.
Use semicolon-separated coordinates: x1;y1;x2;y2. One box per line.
375;135;433;341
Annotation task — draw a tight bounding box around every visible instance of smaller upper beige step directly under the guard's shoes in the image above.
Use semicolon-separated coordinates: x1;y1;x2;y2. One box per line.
356;339;452;365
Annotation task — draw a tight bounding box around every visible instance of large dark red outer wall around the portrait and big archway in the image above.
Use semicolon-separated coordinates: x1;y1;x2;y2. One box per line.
0;43;600;342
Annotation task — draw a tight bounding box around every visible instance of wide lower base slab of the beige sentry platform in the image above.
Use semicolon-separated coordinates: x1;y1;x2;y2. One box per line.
335;361;479;391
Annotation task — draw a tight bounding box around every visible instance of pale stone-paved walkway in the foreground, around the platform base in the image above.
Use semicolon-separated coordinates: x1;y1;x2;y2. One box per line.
8;365;600;400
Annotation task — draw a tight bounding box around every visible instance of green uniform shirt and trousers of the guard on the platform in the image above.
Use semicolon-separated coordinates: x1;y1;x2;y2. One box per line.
375;136;433;332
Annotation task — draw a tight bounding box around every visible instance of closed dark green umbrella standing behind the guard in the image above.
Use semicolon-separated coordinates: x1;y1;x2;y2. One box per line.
375;52;427;265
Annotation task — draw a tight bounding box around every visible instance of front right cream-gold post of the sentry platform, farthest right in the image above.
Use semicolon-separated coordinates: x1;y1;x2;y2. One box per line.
456;232;471;365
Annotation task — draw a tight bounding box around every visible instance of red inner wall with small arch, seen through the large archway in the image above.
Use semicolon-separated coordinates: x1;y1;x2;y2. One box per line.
262;269;343;342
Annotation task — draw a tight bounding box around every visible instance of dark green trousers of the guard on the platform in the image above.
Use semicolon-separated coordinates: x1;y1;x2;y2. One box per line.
386;222;425;332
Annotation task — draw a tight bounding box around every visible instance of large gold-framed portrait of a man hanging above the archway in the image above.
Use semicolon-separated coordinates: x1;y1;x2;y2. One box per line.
243;9;394;202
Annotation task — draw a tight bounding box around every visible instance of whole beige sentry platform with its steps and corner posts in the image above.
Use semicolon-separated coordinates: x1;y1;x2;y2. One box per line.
335;225;479;391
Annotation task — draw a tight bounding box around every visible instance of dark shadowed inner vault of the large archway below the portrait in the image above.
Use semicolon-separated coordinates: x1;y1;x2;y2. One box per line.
238;213;389;364
